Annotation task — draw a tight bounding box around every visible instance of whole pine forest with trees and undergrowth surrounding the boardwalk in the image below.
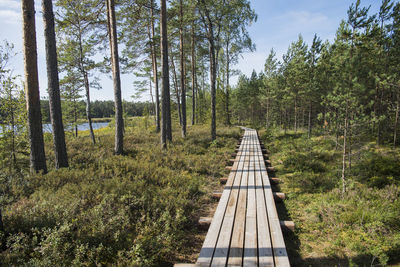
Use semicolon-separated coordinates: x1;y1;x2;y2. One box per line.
0;0;400;266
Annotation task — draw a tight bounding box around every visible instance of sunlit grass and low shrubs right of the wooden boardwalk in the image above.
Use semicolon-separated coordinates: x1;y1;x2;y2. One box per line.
261;131;400;266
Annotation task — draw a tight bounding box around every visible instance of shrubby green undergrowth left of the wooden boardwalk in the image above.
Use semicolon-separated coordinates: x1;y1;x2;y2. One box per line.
0;118;240;266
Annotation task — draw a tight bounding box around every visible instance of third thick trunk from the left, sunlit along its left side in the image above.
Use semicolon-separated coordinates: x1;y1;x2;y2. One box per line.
107;0;124;155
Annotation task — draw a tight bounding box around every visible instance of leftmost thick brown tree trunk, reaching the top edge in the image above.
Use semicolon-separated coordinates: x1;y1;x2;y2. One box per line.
22;0;47;173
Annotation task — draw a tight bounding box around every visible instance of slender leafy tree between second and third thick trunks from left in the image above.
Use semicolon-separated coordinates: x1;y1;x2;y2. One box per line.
56;0;105;144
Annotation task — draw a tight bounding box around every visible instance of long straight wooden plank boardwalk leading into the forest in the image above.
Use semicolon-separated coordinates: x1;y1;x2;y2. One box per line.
175;128;290;267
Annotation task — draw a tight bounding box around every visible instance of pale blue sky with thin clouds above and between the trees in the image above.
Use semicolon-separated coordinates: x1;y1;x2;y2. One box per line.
0;0;381;100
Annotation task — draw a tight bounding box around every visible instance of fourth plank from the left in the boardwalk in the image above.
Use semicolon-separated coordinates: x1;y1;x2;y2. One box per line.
243;138;258;267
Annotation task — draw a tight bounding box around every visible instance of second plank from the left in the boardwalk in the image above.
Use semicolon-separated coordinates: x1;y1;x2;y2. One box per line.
211;136;248;266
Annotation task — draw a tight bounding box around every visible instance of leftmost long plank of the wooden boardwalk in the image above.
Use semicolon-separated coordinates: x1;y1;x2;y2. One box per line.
197;133;246;266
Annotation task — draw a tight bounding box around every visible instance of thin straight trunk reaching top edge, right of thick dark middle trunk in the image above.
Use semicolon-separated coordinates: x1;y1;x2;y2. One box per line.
179;0;186;138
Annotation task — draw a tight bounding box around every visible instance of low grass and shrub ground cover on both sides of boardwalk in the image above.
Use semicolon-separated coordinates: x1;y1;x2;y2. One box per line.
6;120;400;266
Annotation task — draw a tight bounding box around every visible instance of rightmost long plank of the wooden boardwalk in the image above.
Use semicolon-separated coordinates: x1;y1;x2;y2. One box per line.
258;134;290;267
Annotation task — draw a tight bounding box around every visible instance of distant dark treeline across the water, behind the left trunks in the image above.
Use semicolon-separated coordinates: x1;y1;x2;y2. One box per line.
40;100;154;122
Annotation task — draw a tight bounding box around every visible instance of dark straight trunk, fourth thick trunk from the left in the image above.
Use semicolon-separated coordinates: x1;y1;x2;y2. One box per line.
160;0;172;149
